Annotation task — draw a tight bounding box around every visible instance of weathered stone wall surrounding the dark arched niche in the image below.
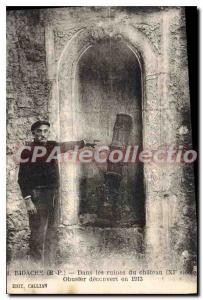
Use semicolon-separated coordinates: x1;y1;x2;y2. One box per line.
7;7;196;266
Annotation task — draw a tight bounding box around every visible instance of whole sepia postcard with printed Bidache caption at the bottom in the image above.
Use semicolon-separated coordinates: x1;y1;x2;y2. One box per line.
6;6;198;295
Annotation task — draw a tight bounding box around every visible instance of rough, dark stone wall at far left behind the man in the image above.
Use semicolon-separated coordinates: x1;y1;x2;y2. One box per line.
7;10;50;259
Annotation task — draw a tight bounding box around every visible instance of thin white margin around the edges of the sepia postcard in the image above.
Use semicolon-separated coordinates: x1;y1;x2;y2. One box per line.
0;0;203;299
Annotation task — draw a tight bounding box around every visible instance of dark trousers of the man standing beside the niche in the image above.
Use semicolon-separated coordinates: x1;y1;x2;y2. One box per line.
29;188;59;266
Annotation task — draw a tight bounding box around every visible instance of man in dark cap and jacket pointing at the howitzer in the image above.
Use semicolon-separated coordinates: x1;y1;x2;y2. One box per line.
18;121;95;265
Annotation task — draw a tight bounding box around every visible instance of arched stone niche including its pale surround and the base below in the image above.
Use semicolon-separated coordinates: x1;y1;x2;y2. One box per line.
54;26;158;263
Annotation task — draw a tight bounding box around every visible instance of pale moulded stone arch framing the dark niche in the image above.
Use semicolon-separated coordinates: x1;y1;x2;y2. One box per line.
49;25;165;264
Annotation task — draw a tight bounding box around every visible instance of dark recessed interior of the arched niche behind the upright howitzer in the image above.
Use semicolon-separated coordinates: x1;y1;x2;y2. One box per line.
74;38;145;227
